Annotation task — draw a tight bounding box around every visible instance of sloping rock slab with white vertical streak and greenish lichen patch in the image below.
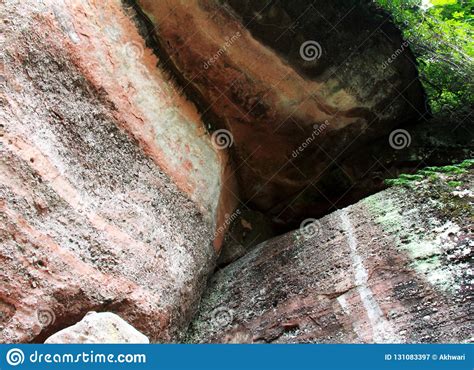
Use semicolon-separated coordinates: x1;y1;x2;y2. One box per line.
189;162;474;343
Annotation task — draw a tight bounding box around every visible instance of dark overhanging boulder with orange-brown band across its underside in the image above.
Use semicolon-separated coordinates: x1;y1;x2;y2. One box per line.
132;0;434;223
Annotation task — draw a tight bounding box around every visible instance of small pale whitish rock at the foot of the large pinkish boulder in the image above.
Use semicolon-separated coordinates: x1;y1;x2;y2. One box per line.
45;312;150;344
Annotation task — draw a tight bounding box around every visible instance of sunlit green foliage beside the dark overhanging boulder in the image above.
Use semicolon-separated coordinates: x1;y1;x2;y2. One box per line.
374;0;474;116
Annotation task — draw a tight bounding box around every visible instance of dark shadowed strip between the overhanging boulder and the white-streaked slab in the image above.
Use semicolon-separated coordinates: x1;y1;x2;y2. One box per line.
272;118;474;230
